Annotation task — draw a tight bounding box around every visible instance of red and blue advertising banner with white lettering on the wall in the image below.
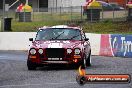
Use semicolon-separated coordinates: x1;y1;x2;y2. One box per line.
100;34;132;57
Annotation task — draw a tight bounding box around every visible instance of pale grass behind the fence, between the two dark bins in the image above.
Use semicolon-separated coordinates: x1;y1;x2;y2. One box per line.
32;13;86;21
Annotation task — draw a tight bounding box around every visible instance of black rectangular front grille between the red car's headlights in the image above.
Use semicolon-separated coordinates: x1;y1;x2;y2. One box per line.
45;48;65;58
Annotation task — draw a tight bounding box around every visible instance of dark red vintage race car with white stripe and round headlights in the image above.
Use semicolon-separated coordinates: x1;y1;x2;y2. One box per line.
27;25;91;70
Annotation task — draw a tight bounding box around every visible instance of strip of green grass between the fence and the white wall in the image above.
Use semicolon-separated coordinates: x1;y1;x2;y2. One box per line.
12;21;132;34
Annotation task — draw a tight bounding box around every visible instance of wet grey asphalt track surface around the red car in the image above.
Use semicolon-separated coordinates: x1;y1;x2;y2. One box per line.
0;51;132;88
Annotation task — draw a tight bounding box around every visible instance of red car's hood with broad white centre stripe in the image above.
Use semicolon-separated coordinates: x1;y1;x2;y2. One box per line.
32;40;83;48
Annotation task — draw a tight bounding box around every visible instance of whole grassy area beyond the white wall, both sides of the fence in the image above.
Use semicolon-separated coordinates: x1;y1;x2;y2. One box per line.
12;12;132;34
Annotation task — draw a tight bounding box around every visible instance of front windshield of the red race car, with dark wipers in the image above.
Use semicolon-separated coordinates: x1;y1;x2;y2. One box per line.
36;28;81;40
